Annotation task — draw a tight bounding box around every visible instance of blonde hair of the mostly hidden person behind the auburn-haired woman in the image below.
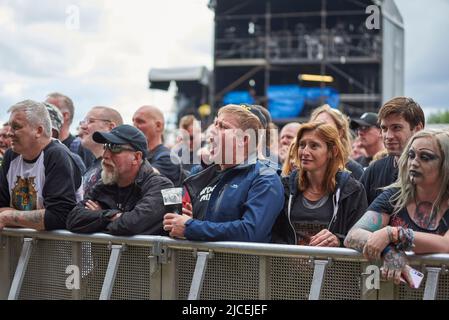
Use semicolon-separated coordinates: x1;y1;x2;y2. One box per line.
310;104;352;161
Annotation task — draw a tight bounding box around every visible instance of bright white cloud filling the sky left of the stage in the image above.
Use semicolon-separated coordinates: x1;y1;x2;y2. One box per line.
0;0;213;127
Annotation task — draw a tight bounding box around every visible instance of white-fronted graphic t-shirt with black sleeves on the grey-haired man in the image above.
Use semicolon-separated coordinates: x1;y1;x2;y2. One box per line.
0;140;82;230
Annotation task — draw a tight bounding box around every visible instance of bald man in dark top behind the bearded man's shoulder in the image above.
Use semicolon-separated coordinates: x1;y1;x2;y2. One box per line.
133;106;183;186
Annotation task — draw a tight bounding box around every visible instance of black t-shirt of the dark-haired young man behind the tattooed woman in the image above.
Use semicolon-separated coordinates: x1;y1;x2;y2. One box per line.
360;156;398;205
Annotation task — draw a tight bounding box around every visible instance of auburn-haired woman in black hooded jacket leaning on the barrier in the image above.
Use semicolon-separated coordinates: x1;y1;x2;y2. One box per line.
273;122;367;247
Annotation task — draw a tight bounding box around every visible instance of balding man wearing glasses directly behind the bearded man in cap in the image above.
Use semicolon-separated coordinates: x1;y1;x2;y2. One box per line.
79;106;123;195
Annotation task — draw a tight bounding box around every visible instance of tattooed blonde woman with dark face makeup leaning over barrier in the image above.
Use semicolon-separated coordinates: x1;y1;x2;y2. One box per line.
345;130;449;284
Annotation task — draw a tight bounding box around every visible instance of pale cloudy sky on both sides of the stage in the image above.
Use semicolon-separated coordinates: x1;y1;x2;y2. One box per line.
0;0;449;127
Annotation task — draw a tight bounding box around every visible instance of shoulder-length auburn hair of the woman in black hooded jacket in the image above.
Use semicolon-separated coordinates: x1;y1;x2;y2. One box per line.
292;122;346;193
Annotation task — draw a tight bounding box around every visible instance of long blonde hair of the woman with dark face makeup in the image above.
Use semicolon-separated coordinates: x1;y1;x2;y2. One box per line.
385;129;449;219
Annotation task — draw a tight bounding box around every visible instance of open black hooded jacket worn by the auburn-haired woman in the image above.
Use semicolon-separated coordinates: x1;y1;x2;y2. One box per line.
273;170;368;246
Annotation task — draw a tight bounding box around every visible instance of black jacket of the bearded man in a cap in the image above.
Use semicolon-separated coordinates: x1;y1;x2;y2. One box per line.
67;161;173;235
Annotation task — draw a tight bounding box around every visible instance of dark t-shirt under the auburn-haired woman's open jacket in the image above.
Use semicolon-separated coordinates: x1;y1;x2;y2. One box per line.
290;193;334;245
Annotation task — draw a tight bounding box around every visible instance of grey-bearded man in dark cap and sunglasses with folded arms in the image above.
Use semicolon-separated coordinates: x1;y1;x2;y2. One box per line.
67;125;173;235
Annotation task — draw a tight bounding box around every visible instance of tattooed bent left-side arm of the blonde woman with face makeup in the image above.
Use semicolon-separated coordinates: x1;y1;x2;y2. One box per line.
345;211;390;260
